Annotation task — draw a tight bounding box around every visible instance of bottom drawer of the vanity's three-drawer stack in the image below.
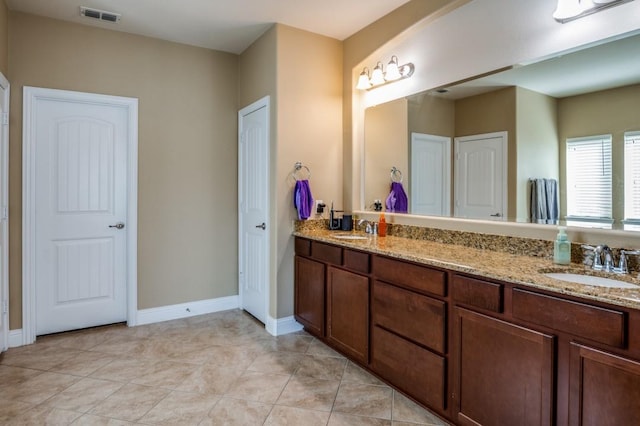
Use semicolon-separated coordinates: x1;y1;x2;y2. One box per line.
371;327;446;410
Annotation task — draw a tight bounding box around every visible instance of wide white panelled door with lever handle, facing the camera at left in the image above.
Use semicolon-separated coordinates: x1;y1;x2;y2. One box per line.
25;88;135;335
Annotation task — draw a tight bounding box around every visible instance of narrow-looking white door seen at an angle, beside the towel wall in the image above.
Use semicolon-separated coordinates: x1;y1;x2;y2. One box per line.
238;97;270;324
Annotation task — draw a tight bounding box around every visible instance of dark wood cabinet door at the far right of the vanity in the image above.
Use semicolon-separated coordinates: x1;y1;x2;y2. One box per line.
569;343;640;426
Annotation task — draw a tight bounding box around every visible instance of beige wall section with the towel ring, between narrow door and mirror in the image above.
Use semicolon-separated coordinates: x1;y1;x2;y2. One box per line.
272;25;343;318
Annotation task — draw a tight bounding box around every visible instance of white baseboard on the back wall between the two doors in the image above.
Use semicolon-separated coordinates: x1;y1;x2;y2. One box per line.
136;296;240;325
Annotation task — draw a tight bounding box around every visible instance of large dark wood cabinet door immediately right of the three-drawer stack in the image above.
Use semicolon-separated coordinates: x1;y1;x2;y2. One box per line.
455;308;554;426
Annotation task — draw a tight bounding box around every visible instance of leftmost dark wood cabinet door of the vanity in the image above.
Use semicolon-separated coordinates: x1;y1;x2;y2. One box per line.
294;256;325;337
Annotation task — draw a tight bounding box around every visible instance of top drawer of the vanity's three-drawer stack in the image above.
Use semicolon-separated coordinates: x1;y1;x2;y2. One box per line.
373;256;446;296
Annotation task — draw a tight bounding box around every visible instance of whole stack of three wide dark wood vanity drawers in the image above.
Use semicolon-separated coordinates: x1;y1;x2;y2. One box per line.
371;256;447;414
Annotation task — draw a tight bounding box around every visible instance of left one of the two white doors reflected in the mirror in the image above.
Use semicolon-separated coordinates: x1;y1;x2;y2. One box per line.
409;133;451;216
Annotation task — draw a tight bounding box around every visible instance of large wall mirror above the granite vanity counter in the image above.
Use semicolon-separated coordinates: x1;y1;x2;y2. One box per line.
363;35;640;229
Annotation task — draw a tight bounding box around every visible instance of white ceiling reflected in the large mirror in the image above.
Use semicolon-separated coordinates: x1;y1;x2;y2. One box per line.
432;34;640;99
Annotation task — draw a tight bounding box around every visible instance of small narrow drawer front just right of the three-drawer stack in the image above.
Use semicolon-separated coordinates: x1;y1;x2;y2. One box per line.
451;275;504;313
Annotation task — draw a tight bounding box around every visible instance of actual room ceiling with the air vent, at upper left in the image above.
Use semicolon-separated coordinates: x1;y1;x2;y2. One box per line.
6;0;409;54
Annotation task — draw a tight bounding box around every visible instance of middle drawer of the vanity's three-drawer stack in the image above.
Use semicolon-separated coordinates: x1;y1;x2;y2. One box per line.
372;281;446;353
